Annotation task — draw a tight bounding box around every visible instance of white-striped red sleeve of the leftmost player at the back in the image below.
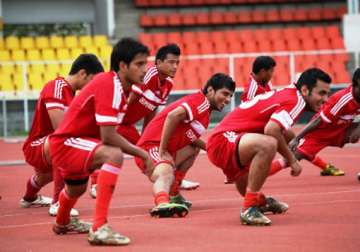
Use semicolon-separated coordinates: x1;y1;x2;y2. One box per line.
41;80;69;110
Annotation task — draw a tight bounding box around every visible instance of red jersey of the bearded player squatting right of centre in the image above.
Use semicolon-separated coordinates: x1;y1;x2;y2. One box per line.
213;85;305;135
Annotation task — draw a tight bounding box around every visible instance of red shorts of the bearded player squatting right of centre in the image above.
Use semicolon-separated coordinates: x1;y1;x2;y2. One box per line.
206;131;249;182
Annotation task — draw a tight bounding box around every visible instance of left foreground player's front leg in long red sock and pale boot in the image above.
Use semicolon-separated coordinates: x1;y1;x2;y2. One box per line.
88;145;130;245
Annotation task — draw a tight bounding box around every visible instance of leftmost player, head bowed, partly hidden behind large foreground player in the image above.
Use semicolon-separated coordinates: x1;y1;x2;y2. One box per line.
20;54;104;216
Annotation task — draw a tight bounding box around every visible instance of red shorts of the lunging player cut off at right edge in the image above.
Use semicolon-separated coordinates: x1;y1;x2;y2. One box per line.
297;127;348;160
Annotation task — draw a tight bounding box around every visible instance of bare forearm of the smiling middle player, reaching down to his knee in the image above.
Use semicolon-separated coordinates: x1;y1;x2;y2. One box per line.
159;107;187;161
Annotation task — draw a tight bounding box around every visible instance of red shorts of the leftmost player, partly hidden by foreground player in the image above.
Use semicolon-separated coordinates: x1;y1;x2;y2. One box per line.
23;136;52;173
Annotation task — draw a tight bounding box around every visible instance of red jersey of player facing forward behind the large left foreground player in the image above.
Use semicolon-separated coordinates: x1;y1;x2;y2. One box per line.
123;66;173;125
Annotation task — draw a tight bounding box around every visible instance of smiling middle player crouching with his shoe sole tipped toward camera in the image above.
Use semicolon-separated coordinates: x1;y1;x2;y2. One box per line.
135;73;235;217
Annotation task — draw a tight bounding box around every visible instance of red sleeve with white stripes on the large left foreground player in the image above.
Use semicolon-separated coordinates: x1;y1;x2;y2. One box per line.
94;77;125;126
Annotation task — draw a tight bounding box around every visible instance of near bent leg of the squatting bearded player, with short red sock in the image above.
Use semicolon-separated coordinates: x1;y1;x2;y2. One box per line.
236;134;277;225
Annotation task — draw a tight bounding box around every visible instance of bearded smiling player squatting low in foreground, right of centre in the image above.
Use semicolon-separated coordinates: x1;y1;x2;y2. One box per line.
207;68;331;225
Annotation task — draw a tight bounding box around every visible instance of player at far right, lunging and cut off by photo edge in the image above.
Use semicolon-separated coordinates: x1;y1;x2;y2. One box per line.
270;68;360;176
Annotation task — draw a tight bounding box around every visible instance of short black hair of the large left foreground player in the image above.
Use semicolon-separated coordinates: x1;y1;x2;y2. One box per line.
110;38;149;72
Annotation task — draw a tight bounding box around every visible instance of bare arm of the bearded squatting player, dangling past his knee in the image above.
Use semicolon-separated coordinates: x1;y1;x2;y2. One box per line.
264;121;301;176
